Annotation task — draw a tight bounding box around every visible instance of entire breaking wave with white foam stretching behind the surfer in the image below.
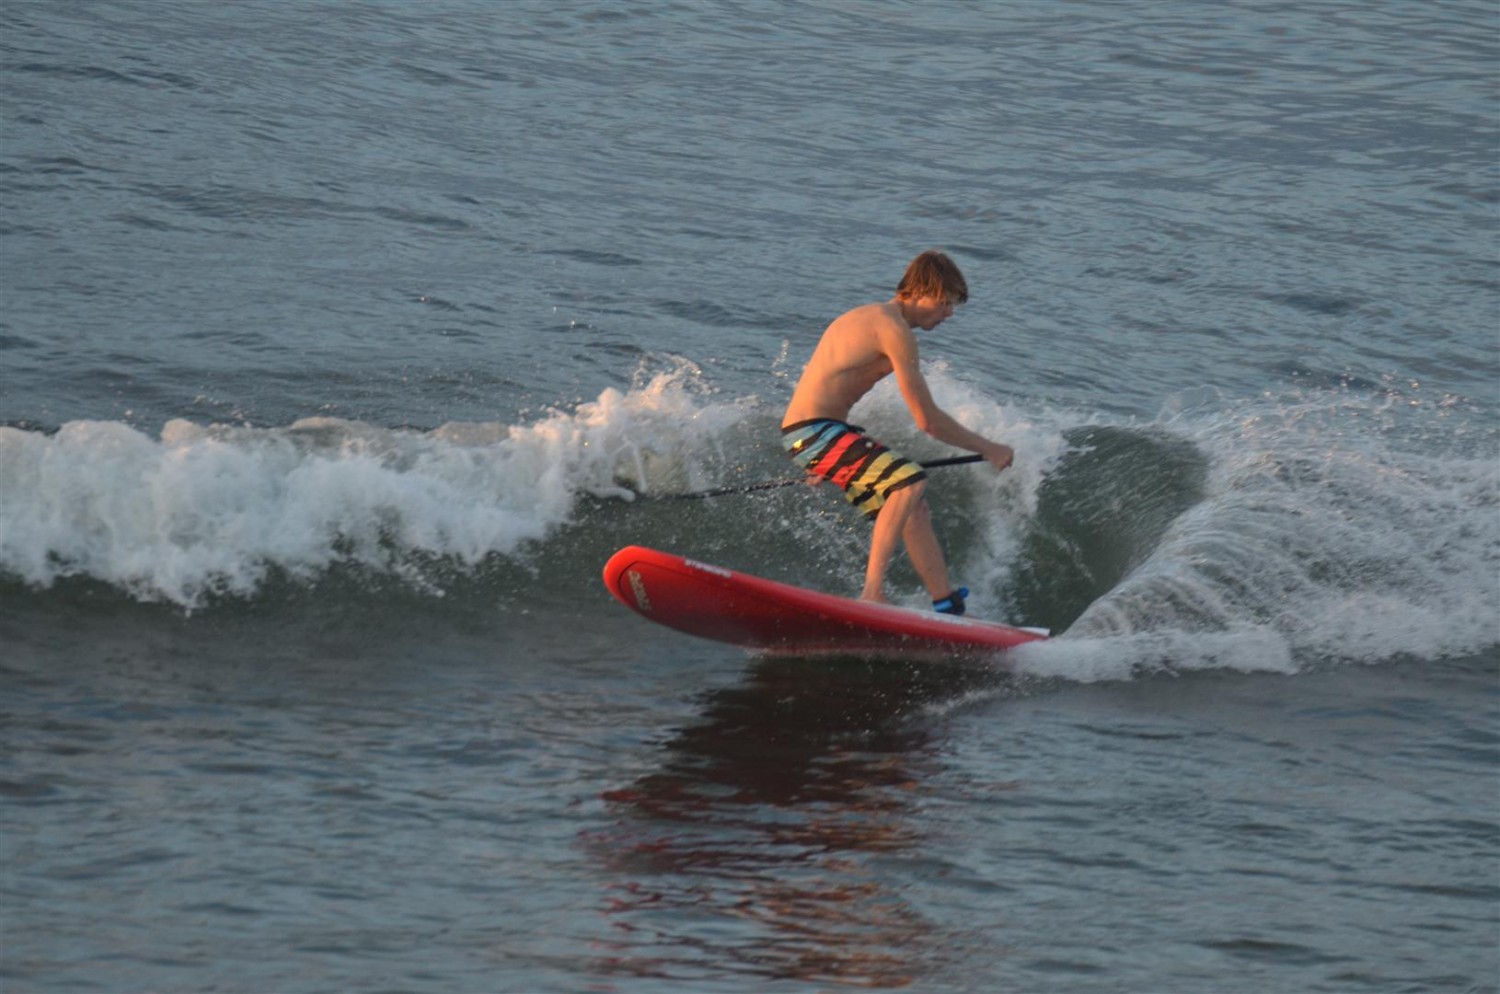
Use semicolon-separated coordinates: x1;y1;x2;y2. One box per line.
0;361;1500;679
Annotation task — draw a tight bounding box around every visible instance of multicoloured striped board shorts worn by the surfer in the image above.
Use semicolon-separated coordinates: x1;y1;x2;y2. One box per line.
782;418;927;519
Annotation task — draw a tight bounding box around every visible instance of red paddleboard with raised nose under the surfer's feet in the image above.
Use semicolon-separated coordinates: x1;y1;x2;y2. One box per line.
605;546;1047;658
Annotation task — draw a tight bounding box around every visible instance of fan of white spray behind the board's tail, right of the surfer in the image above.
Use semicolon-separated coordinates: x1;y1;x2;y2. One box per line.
1017;390;1500;681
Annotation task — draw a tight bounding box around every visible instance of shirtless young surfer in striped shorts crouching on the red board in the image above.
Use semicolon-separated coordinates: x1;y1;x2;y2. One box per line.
782;252;1016;615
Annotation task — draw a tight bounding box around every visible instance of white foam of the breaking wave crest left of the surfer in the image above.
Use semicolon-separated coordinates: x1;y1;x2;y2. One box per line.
0;364;743;607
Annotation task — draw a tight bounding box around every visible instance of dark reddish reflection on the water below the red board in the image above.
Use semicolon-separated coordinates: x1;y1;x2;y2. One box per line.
588;660;996;988
